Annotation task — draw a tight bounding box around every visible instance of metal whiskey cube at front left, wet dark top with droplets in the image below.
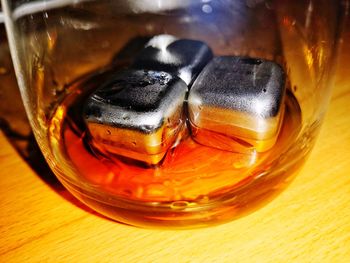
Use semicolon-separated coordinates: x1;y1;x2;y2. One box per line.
84;70;187;164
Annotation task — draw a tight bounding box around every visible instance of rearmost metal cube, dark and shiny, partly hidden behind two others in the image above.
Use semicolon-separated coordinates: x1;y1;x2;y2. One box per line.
132;35;213;85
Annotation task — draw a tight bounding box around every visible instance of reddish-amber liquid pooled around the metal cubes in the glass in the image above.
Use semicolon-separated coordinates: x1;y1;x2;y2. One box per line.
49;67;301;228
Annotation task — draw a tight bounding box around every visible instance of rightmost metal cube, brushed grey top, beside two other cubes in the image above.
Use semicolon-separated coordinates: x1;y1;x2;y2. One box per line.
188;56;285;152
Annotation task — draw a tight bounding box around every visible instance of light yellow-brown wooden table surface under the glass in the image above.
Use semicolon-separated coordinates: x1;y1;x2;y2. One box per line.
0;28;350;262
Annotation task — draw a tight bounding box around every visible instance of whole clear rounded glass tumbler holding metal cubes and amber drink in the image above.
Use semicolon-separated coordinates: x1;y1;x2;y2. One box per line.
2;0;349;228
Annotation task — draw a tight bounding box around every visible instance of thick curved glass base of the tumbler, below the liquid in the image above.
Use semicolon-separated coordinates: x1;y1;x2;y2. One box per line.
58;156;306;229
